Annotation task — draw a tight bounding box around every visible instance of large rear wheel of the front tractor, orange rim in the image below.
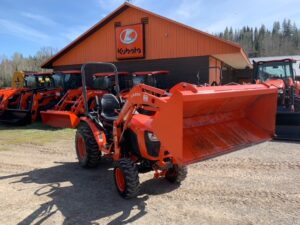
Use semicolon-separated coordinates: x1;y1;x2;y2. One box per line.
75;122;101;168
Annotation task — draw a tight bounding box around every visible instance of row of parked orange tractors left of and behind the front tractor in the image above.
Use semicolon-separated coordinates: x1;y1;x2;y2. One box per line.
0;70;168;128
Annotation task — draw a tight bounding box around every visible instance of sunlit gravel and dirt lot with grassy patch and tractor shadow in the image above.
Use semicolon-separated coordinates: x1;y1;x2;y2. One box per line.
0;125;300;225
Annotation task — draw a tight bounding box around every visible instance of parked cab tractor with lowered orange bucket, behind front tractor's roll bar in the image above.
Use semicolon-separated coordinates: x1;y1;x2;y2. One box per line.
41;72;132;128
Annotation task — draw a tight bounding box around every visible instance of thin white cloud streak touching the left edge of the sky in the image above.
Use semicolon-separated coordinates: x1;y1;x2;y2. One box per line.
0;18;50;43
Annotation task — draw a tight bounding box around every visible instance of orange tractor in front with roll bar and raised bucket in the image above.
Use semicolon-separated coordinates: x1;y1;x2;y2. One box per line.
75;63;277;198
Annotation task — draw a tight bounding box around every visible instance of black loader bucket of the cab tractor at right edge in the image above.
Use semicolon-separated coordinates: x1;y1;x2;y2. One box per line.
276;112;300;141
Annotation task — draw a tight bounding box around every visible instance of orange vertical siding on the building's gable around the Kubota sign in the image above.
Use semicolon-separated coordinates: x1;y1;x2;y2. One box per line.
53;8;240;66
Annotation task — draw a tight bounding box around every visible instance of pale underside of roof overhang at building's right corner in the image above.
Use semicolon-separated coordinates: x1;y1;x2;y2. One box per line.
212;48;253;69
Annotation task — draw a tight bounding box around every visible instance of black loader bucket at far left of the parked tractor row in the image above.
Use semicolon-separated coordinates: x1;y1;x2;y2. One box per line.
0;109;31;125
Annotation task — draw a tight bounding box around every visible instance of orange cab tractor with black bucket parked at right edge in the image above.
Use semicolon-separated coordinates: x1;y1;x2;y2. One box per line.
254;59;300;140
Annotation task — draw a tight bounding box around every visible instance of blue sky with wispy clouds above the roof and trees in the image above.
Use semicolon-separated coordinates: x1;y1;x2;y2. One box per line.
0;0;300;59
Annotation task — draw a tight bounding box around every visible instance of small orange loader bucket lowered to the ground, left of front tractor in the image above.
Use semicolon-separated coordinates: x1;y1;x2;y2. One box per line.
41;110;80;128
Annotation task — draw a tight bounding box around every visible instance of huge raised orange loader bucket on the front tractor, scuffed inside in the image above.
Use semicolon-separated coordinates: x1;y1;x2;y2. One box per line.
152;84;277;164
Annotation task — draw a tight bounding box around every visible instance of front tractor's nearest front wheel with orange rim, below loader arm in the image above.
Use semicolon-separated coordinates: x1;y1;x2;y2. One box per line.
114;158;140;199
